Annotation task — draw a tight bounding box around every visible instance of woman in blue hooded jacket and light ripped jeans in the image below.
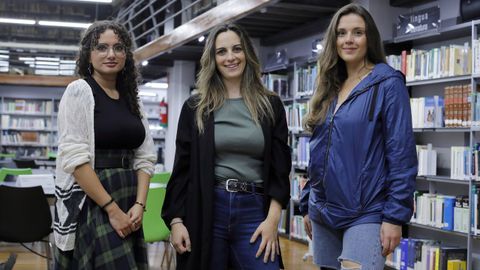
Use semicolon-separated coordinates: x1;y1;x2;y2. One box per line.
301;4;417;269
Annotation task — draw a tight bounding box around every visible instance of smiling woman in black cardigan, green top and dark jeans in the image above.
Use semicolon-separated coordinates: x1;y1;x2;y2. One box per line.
162;24;291;270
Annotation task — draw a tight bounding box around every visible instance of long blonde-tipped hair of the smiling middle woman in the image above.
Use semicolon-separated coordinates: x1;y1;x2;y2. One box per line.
195;24;274;133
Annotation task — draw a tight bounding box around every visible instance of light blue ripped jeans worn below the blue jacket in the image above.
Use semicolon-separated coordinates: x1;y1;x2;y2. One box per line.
312;221;385;270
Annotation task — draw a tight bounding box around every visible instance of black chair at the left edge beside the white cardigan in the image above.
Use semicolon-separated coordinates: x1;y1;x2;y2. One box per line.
0;185;52;268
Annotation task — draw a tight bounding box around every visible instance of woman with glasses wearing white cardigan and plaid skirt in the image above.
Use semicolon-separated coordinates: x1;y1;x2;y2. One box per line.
54;21;156;269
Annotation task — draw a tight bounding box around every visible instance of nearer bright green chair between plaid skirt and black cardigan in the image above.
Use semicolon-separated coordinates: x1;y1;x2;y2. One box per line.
143;187;175;269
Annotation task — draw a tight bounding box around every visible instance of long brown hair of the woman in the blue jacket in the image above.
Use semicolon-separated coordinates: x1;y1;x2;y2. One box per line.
304;3;385;132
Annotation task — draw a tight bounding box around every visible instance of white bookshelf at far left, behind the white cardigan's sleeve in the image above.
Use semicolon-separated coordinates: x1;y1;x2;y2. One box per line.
0;97;59;157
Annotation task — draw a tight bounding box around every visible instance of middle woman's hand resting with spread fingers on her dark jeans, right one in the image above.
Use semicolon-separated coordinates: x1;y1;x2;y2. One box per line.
250;218;280;263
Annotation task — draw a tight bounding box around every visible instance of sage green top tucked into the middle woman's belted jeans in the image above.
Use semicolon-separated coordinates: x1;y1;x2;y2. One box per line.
214;98;265;183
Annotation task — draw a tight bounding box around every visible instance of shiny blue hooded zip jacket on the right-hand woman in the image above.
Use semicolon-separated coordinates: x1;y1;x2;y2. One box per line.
300;64;417;229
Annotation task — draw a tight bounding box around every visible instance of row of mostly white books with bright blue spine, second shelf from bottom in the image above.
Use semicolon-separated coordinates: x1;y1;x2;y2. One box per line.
411;191;470;233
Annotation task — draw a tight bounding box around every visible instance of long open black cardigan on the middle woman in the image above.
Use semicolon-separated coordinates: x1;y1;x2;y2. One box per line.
162;96;292;270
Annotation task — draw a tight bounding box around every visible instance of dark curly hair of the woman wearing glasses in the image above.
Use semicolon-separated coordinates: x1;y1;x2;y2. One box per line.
77;21;141;117
